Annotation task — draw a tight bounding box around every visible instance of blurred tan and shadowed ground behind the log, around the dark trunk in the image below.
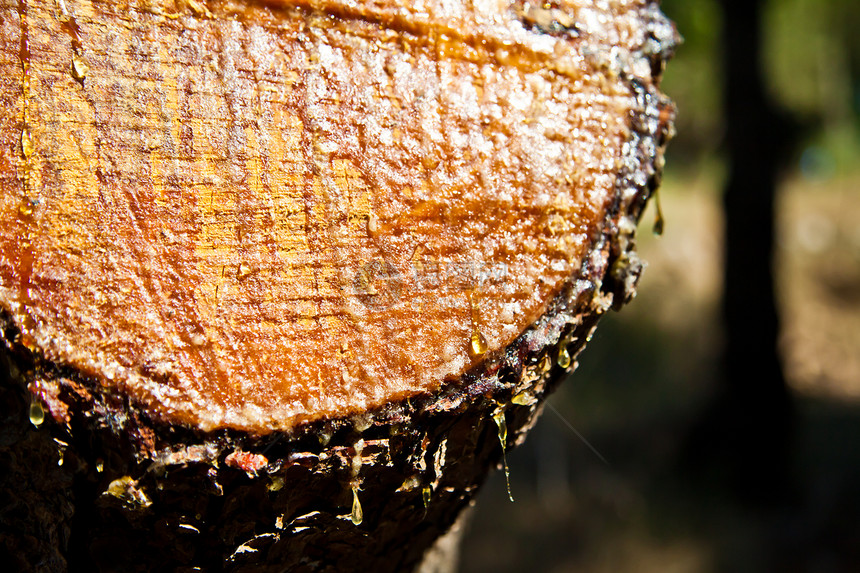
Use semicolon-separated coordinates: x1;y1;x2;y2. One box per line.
461;162;860;573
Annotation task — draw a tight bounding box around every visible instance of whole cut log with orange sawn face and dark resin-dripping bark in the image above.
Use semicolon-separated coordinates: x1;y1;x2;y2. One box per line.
0;0;677;571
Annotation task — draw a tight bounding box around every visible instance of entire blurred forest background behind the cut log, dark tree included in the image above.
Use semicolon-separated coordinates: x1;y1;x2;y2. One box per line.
461;0;860;573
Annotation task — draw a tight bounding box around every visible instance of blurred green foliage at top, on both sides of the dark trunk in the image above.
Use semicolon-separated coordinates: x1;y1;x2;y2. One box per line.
662;0;860;170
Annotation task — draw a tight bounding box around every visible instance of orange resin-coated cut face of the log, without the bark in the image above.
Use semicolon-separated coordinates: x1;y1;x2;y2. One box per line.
0;0;672;428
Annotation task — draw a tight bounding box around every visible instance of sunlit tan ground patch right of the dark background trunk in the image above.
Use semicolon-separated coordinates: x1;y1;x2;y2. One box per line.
777;174;860;400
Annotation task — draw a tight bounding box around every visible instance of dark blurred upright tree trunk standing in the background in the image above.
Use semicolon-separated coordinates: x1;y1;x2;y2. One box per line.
689;0;794;503
